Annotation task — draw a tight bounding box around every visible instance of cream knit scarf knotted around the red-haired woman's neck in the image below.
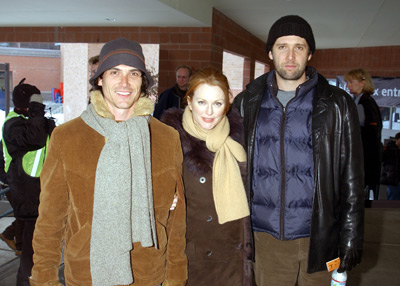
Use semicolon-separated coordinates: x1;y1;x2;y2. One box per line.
182;107;250;224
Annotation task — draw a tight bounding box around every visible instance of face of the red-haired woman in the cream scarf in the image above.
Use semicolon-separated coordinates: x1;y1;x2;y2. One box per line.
188;83;228;130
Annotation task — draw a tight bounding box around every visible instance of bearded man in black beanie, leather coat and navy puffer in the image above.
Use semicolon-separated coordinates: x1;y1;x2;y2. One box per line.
235;15;364;286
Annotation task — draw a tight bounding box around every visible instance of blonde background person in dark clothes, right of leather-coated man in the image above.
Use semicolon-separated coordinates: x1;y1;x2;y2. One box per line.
344;69;382;200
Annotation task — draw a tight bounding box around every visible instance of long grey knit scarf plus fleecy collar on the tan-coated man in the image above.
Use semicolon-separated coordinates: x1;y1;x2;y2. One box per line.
81;91;157;286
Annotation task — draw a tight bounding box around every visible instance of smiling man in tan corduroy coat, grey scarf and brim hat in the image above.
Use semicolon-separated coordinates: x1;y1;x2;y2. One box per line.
31;38;187;286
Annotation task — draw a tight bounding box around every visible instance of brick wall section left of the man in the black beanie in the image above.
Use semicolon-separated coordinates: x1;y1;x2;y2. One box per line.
0;9;266;91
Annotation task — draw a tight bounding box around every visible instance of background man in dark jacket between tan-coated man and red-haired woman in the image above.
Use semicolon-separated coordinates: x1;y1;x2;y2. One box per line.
153;65;192;119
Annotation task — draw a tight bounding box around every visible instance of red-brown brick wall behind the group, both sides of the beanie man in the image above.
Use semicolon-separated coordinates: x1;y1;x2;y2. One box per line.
0;9;400;91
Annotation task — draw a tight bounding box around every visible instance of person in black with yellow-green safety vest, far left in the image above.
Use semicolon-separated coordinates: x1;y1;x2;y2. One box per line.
2;78;55;285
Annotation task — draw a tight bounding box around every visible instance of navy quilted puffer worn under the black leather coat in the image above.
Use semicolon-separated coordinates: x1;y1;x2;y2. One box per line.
252;70;318;240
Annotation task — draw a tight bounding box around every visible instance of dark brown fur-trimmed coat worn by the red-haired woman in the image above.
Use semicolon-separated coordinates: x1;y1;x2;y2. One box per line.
162;108;252;286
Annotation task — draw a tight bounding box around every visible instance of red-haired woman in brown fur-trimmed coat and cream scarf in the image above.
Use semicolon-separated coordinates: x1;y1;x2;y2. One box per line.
162;68;252;286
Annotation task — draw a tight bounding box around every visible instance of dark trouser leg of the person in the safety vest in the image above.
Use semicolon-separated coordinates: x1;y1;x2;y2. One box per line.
17;220;36;286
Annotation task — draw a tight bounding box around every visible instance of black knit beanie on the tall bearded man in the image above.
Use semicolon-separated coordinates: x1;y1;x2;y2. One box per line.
265;15;315;54
